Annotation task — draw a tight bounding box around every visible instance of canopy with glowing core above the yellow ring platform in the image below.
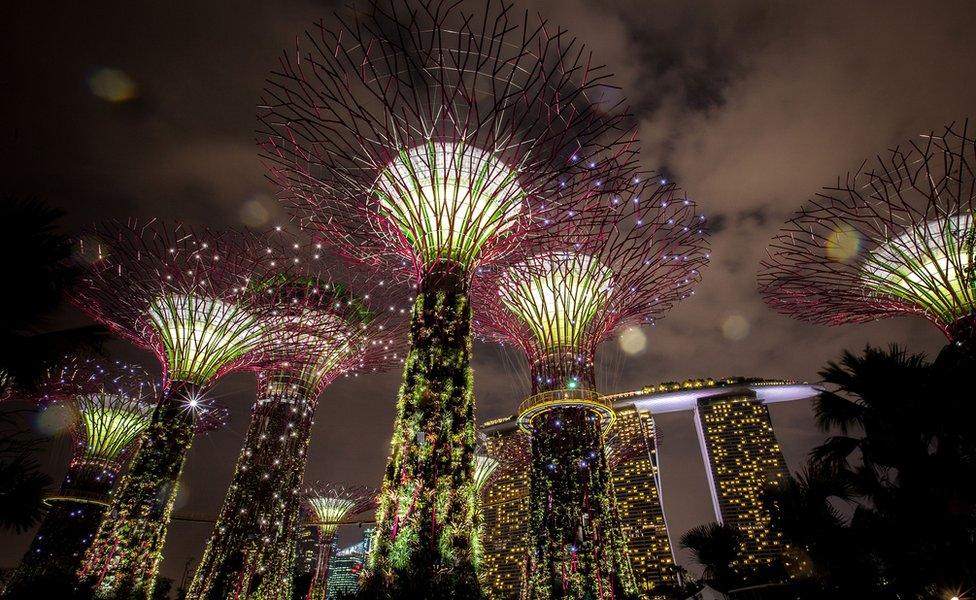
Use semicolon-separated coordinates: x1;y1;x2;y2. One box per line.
472;172;709;392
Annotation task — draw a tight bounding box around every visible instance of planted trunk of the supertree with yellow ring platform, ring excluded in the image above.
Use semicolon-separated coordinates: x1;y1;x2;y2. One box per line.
526;357;637;600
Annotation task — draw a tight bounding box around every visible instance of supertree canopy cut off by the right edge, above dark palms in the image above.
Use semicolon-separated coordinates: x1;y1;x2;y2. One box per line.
759;122;976;350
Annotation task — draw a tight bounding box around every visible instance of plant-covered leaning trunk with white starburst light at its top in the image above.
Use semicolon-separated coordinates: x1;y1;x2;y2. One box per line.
79;382;200;599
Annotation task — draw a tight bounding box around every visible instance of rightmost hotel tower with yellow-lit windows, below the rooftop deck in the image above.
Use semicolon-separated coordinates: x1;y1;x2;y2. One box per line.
695;388;789;565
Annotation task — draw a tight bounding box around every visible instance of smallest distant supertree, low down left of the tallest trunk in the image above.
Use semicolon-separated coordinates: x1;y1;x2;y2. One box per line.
304;483;376;600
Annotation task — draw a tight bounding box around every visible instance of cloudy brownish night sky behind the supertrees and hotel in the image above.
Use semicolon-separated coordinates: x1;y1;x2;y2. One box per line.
0;0;976;583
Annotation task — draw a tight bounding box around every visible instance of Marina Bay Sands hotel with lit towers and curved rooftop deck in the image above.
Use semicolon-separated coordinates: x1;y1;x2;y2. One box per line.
482;377;818;599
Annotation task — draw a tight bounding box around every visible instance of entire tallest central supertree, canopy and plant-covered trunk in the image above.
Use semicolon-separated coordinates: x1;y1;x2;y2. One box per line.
260;0;632;598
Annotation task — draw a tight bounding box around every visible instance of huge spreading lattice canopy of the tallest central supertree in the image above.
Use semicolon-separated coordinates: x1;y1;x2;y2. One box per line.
260;1;635;283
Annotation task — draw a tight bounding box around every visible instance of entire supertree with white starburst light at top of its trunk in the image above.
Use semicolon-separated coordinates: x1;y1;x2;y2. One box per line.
73;221;271;598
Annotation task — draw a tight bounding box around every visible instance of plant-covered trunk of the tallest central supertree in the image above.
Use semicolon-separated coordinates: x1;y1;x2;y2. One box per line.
364;273;481;598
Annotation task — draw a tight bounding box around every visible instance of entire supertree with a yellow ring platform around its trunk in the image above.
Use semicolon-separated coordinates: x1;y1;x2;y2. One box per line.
474;174;708;599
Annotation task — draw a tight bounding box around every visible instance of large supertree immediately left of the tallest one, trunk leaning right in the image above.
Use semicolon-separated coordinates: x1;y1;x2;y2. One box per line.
188;243;404;598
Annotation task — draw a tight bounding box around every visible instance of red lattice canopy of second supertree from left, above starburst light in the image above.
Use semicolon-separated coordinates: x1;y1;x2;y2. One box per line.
72;219;289;387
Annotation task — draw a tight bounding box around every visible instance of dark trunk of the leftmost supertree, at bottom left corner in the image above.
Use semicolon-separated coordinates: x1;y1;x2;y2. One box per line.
3;460;117;599
